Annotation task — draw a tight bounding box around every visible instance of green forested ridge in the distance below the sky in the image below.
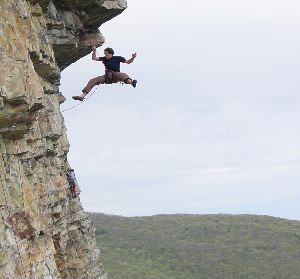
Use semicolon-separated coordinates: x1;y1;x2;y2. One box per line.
90;213;300;279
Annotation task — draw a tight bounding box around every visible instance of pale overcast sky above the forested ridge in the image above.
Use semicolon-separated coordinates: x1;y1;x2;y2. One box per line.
61;0;300;220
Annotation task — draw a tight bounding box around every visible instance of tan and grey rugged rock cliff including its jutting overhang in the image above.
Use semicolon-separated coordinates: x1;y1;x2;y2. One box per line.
0;0;127;279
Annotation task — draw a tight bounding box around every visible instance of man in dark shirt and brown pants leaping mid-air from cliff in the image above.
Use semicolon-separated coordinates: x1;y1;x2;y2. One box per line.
72;46;137;101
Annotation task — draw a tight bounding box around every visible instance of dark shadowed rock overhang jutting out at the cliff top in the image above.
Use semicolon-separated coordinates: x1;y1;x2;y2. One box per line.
29;0;127;70
